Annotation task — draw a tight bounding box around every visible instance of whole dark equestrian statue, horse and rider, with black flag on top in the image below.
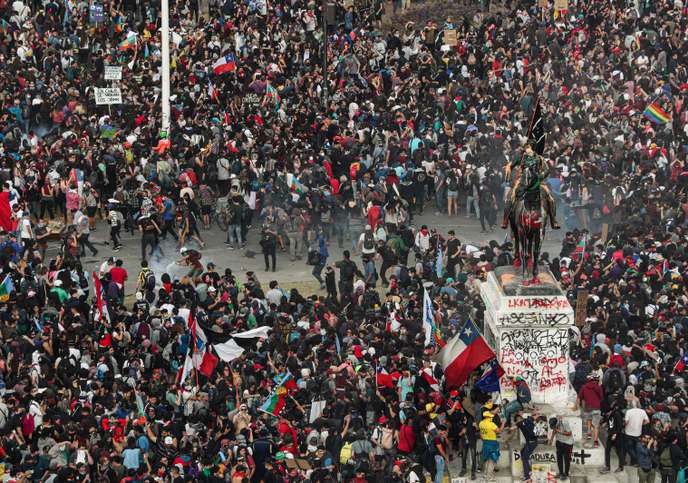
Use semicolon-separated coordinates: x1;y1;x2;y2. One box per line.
502;102;560;285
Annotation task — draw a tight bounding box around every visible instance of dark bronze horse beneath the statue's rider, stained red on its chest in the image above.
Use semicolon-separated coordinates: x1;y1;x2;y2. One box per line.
509;167;547;285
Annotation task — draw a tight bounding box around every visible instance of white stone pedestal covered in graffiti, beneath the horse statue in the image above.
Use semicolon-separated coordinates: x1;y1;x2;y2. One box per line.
481;267;574;411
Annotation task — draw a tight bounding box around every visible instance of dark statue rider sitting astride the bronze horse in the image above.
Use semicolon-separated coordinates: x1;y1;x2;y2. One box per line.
502;143;561;230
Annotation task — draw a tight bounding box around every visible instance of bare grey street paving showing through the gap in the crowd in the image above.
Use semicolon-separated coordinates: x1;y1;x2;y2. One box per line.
56;210;562;294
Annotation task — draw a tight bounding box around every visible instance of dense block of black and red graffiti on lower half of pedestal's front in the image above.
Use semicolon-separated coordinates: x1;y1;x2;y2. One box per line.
499;329;569;391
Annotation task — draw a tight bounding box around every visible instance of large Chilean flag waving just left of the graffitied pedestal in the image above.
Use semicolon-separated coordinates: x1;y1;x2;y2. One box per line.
435;320;495;389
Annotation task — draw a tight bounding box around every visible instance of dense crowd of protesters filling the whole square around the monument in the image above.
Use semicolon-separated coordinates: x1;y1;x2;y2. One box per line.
0;0;688;483
